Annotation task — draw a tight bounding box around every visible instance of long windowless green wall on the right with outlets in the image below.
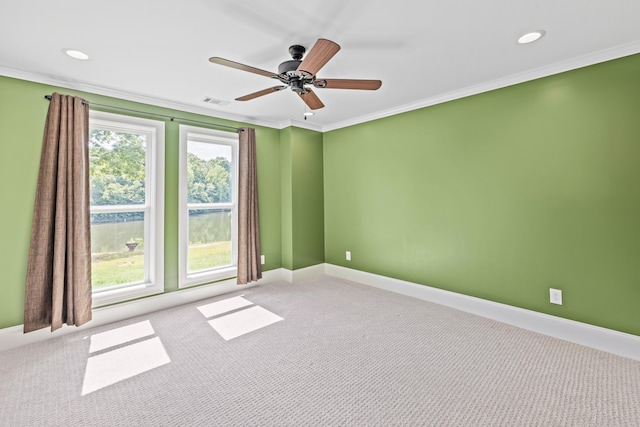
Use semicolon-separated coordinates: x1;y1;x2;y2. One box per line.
324;55;640;335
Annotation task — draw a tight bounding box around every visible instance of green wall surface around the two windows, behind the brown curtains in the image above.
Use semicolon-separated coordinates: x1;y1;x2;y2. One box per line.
0;76;282;328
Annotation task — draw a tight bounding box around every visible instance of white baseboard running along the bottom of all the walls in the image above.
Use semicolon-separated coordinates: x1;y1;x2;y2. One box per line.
5;264;640;360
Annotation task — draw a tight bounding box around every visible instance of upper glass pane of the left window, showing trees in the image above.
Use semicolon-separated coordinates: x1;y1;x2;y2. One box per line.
89;128;147;206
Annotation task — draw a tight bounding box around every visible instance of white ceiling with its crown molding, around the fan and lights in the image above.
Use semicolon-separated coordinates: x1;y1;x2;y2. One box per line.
0;0;640;130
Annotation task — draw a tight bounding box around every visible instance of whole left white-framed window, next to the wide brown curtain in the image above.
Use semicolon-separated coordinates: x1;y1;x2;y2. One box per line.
89;111;164;307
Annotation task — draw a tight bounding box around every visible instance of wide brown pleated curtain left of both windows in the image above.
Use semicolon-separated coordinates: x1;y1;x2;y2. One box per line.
24;93;91;333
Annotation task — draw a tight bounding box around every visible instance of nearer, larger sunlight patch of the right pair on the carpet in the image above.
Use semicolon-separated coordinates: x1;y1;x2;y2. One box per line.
209;306;284;341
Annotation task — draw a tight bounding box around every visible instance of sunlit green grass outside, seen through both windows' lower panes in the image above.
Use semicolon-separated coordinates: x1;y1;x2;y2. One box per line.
91;241;231;289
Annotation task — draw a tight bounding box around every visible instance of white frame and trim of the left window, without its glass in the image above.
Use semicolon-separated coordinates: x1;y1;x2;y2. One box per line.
89;110;165;308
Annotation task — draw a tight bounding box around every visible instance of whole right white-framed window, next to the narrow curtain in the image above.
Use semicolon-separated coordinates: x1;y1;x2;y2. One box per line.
178;125;238;287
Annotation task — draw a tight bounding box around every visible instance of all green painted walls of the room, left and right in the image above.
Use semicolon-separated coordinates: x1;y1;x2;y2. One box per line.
0;55;640;335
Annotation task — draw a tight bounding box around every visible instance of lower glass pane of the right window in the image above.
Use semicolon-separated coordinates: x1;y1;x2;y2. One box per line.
187;209;233;272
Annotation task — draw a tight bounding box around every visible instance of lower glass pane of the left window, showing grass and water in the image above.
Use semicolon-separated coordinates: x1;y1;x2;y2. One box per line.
91;212;145;291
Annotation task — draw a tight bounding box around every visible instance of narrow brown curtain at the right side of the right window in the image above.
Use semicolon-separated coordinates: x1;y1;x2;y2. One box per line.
238;128;262;285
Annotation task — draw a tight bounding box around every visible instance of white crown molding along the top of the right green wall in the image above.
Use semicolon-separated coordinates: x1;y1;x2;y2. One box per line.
322;40;640;132
